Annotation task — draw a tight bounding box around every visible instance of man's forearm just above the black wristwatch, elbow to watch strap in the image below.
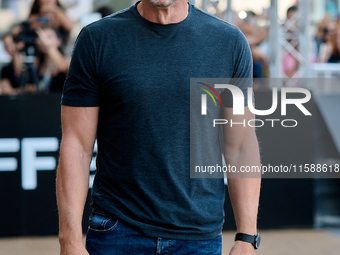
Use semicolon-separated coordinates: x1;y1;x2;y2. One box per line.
225;136;261;234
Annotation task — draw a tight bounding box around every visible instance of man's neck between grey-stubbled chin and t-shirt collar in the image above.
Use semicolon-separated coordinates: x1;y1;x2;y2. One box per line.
137;0;189;25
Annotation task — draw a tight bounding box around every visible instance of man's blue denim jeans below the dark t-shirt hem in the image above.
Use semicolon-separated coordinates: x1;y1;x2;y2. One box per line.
86;211;222;255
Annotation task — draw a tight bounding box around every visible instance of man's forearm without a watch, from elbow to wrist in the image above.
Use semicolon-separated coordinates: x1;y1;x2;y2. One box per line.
57;138;92;245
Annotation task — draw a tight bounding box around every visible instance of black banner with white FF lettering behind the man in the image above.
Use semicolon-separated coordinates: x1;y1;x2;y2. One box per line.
0;92;314;236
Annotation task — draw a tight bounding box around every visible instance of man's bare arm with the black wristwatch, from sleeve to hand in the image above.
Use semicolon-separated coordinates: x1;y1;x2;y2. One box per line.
224;104;261;255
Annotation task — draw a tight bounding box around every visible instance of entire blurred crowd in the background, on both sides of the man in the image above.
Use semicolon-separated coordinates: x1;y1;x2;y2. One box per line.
0;0;340;95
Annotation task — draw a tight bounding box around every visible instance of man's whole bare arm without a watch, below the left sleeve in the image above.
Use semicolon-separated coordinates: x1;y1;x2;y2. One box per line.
57;106;99;255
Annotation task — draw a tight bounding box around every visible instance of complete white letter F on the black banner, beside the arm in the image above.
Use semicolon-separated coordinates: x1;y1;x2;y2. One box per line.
21;137;59;190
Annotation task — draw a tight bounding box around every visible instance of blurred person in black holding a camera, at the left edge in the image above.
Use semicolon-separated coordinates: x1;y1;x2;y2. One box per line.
1;21;70;95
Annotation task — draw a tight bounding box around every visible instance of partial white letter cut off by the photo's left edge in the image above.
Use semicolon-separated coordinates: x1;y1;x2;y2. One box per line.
0;138;20;172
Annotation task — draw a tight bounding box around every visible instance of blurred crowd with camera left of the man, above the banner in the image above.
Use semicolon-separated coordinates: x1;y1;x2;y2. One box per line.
0;0;113;95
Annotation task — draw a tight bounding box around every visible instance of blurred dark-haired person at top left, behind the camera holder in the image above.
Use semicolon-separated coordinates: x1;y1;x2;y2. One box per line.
29;0;74;47
